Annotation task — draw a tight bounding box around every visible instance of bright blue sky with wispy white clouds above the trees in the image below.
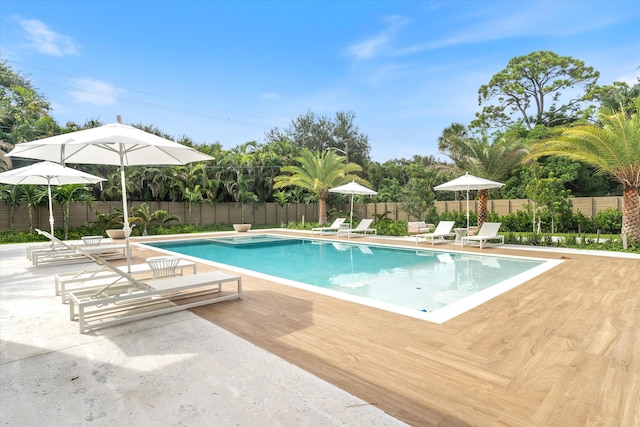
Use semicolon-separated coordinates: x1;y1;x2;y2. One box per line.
0;0;640;162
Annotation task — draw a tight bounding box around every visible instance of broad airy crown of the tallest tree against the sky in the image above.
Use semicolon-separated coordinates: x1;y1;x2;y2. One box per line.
471;51;600;130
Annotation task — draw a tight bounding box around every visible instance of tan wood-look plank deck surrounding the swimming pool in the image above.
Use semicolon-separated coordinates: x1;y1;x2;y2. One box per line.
130;233;640;426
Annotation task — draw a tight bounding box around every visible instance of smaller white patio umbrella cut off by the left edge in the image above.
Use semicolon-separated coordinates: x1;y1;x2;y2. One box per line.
0;161;106;244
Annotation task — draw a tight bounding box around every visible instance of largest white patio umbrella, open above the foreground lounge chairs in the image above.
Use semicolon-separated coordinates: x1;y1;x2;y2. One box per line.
8;117;213;271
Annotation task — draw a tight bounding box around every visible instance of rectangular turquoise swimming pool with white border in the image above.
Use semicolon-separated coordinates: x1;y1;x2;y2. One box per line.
147;234;558;323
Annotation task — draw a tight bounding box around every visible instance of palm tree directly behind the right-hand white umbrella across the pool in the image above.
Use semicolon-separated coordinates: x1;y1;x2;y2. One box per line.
441;133;529;227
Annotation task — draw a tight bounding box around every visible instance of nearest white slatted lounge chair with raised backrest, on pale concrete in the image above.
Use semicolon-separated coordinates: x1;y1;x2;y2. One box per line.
38;231;242;333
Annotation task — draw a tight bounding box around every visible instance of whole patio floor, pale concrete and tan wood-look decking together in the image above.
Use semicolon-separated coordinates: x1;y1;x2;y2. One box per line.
0;232;640;426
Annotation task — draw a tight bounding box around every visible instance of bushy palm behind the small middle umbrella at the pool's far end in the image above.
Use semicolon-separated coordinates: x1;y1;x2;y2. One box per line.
274;149;369;225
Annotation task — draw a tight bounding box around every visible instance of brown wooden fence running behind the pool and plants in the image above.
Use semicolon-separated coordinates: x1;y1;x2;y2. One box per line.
0;197;622;231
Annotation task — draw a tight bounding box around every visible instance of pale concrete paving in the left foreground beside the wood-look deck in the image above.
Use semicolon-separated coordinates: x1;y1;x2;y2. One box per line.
0;245;405;426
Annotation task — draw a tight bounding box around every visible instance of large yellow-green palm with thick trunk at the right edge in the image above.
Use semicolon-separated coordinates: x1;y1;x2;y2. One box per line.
529;96;640;242
